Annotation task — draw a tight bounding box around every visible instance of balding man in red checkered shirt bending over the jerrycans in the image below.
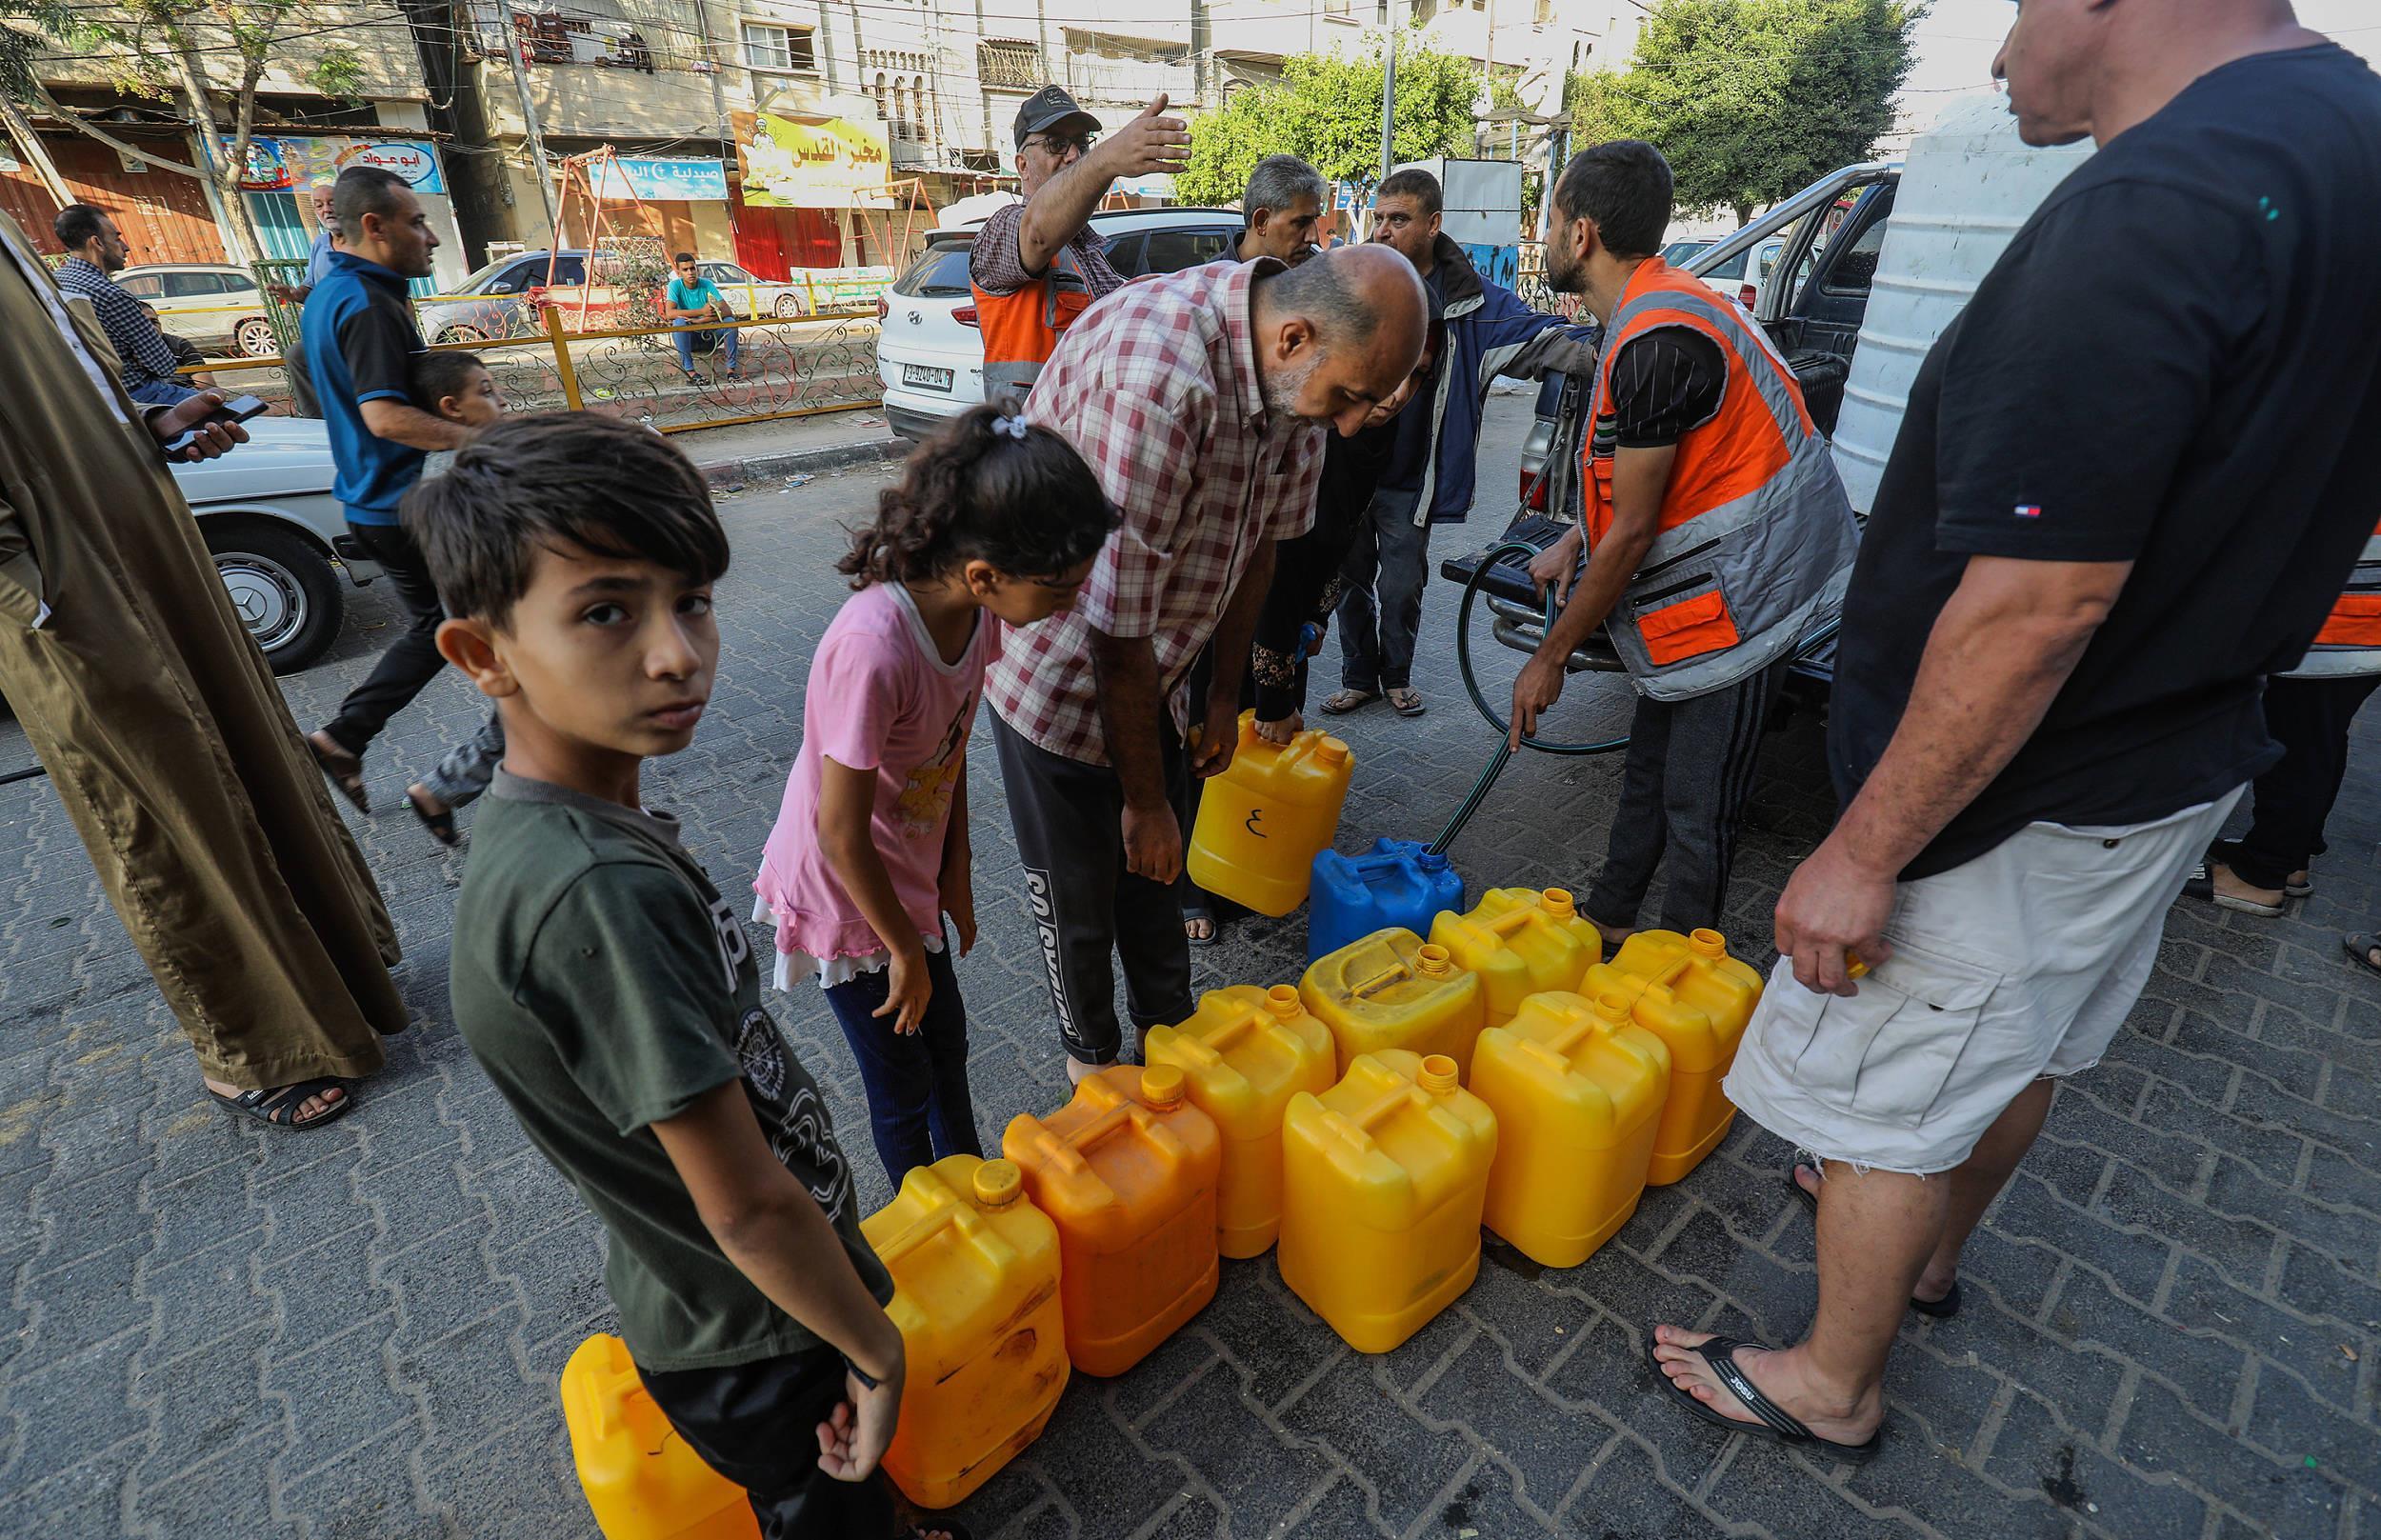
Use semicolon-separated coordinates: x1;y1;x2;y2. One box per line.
984;248;1427;1078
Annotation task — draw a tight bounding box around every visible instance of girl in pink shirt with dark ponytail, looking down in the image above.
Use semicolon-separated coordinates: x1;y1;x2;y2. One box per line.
752;407;1114;1188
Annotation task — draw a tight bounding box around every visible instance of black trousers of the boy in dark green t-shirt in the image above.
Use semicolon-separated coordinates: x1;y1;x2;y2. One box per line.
636;1351;893;1540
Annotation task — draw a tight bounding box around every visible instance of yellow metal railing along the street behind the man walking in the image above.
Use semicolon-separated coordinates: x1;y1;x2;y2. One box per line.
184;305;881;433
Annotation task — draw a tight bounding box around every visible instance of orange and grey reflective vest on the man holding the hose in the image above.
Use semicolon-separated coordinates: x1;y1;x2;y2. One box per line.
1581;257;1860;700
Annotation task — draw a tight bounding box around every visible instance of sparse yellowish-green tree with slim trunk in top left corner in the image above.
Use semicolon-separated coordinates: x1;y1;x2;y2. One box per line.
0;0;362;262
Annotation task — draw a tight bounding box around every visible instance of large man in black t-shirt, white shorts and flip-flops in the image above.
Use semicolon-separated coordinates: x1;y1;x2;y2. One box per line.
1655;0;2381;1459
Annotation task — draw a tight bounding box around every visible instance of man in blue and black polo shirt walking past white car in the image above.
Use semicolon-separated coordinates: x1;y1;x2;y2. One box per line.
305;167;471;811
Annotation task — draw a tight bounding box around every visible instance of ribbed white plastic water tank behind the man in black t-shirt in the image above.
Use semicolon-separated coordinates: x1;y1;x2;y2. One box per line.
1836;92;2091;514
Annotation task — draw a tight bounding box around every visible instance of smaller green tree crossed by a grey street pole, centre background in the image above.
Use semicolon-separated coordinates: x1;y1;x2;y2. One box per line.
1174;38;1481;202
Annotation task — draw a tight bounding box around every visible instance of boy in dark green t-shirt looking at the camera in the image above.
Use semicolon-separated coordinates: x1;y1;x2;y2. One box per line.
405;411;950;1540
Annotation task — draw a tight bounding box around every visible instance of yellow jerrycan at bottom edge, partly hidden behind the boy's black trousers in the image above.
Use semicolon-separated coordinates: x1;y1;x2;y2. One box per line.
562;1333;760;1540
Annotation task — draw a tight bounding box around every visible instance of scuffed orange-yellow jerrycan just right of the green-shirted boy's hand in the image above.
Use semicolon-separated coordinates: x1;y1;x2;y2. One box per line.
860;1154;1067;1510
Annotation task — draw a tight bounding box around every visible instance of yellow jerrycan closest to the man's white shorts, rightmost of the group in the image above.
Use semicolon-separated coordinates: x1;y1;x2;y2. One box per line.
1581;930;1762;1188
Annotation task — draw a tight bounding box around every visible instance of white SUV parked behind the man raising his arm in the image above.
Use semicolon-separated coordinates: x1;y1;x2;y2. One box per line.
876;210;1243;438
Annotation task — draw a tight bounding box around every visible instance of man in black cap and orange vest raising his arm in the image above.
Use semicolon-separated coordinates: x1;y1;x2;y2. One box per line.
967;86;1190;400
